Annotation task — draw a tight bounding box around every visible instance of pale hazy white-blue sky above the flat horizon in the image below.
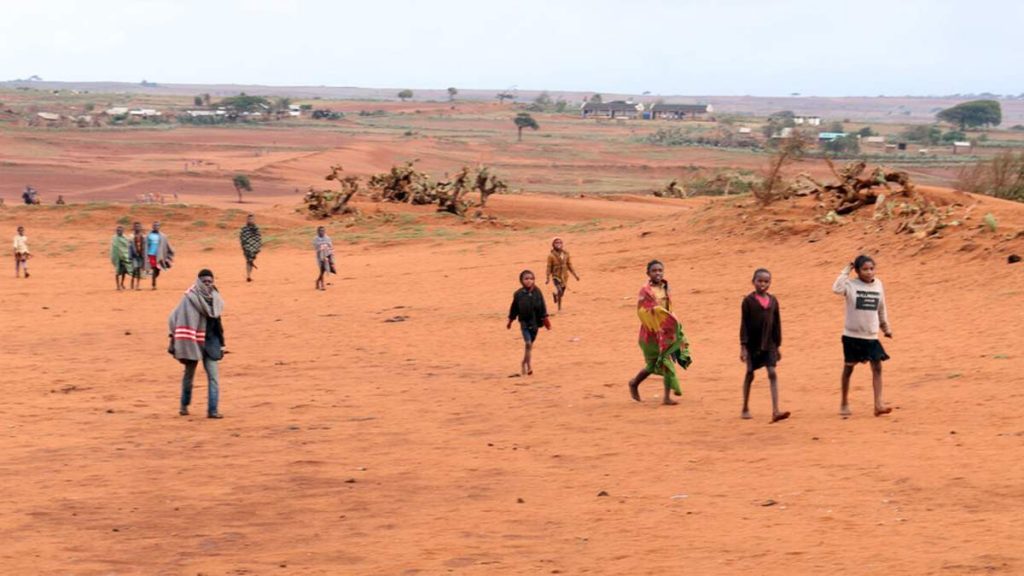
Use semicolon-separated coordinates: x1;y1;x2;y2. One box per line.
0;0;1024;95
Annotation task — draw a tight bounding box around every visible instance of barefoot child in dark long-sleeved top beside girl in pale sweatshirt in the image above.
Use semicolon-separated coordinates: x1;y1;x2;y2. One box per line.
739;269;790;422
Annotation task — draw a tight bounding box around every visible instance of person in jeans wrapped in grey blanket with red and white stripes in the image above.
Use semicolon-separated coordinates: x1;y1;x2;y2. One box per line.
167;270;224;418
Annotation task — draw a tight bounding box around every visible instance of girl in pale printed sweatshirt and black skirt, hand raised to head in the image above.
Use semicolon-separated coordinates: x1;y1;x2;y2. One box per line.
833;254;893;416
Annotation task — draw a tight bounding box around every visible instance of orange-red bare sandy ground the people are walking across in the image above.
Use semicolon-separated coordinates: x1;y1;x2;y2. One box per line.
0;124;1024;575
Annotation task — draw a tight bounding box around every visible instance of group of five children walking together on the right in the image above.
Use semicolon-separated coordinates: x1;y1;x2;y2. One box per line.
507;238;893;422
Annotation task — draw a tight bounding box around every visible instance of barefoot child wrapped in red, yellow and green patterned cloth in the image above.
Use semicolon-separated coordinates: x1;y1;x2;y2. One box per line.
630;260;692;406
